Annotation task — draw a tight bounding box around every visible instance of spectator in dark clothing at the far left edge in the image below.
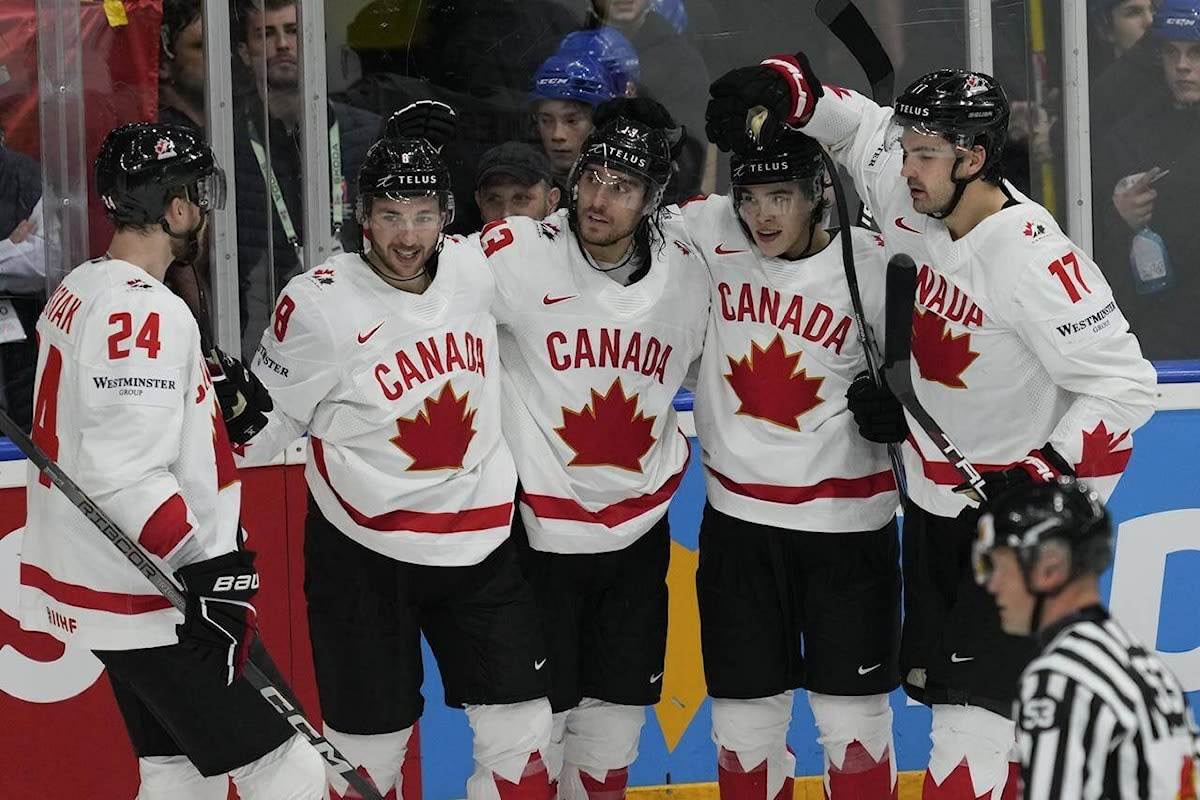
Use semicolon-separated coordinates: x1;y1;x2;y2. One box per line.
0;127;46;431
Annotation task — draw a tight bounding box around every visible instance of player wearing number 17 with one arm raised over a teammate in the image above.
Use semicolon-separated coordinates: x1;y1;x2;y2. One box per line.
708;54;1156;800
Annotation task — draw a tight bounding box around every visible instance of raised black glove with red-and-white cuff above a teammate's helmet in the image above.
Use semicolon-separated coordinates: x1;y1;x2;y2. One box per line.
704;53;824;152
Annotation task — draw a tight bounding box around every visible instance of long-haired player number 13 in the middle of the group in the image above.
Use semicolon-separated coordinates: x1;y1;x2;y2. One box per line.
480;100;708;800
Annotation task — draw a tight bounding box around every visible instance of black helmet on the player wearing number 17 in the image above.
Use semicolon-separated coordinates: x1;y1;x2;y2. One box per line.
894;70;1009;182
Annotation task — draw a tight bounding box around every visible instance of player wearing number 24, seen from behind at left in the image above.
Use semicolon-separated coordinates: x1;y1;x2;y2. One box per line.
20;122;325;800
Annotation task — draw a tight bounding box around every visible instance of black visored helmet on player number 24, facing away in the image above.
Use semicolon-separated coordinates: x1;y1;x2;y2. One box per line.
95;122;224;227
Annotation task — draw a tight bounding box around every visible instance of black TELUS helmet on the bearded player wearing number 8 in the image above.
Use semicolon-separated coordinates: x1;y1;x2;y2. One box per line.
358;139;454;225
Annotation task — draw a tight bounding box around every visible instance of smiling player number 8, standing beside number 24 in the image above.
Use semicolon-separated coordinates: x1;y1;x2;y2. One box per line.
246;139;552;800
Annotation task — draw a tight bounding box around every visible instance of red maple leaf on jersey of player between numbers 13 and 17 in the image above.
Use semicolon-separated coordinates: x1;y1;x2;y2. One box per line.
725;333;824;431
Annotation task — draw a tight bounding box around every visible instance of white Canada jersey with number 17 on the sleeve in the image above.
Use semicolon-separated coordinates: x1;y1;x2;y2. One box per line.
804;86;1156;517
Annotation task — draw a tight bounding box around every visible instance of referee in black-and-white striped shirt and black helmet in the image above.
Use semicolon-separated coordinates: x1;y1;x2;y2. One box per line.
974;477;1198;800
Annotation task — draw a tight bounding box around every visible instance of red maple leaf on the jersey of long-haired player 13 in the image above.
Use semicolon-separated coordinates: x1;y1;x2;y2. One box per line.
554;378;658;473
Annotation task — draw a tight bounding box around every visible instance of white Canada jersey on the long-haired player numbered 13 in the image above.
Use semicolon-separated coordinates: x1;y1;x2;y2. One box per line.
480;210;708;553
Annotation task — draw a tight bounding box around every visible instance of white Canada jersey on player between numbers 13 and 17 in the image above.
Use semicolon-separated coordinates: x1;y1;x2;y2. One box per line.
683;197;898;531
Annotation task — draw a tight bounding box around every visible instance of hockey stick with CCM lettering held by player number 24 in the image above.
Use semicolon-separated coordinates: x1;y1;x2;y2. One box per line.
0;410;383;800
